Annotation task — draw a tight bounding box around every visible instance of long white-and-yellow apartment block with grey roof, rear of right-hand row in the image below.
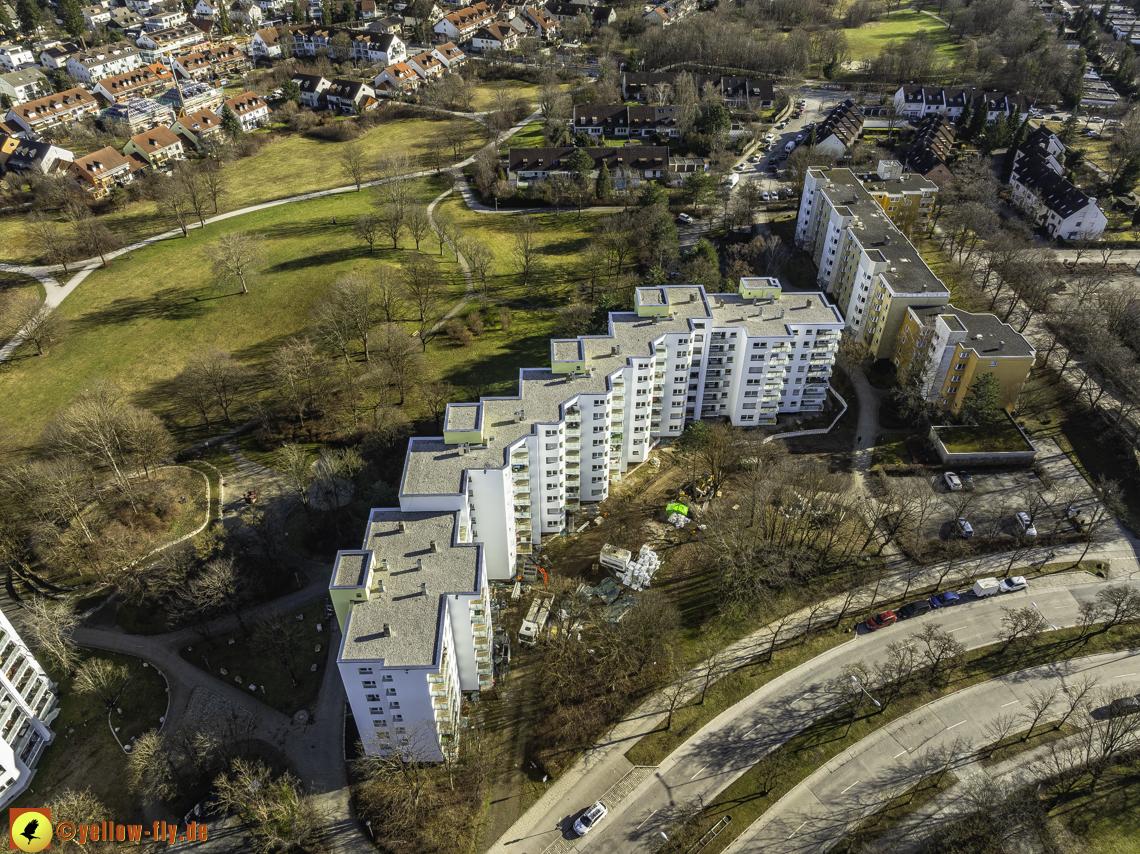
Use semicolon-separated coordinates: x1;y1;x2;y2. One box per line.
796;161;950;358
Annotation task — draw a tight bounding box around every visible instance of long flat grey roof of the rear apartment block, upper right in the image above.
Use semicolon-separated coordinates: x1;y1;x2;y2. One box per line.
812;169;950;299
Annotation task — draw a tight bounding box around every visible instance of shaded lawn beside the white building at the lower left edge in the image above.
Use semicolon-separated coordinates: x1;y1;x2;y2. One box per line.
13;650;168;816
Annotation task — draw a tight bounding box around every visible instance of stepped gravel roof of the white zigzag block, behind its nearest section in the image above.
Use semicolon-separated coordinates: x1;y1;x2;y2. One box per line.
400;285;841;495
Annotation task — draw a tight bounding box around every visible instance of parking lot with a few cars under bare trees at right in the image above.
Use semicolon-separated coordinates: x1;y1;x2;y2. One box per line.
891;439;1093;539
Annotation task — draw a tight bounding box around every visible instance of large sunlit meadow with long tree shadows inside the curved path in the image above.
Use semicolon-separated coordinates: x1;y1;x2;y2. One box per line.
0;180;463;444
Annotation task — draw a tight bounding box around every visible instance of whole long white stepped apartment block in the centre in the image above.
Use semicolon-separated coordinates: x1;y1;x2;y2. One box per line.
329;278;844;758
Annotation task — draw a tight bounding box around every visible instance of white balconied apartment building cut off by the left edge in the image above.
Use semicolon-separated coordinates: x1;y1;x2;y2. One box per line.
0;612;59;807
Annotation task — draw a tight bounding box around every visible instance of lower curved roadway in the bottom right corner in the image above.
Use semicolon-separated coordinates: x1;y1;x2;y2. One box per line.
725;650;1140;854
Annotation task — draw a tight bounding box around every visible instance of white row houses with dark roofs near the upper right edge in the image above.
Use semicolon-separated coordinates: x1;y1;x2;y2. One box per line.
1007;125;1108;241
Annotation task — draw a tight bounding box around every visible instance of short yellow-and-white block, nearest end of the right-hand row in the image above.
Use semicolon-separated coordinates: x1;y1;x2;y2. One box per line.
893;306;1036;414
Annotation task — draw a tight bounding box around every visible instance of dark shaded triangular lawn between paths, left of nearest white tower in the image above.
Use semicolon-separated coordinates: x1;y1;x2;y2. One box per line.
181;602;329;715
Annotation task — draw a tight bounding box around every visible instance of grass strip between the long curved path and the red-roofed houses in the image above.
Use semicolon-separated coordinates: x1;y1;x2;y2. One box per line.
0;116;486;262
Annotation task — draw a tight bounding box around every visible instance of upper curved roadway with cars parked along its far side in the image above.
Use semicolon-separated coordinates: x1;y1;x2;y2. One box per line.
551;576;1140;854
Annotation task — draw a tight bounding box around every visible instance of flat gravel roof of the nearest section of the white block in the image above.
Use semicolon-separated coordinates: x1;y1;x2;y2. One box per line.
334;509;482;667
